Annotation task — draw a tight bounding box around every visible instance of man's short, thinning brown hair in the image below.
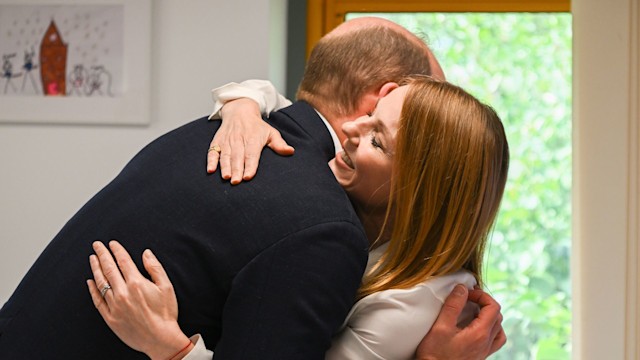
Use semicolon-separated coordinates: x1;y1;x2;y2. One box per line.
296;26;431;116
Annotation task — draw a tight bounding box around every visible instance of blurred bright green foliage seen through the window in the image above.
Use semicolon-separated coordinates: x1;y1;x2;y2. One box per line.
349;13;572;360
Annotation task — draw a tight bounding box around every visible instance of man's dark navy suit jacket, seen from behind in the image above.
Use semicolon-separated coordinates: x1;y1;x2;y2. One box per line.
0;102;368;359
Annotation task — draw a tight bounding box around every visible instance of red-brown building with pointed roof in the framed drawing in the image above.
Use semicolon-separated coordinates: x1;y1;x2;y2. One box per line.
40;20;67;96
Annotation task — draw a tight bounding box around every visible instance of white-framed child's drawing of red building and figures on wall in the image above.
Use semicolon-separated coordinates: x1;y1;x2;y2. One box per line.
0;0;151;124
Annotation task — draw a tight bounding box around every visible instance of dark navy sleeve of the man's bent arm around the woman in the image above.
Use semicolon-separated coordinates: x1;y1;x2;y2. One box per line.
215;221;367;359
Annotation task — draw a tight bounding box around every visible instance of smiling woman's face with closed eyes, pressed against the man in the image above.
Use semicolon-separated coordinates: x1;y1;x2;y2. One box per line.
329;86;407;208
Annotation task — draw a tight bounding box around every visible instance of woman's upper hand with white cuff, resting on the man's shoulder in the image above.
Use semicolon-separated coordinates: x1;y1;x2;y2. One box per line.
207;80;294;185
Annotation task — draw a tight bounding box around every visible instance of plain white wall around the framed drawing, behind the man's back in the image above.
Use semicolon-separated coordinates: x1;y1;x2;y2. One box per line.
0;0;287;306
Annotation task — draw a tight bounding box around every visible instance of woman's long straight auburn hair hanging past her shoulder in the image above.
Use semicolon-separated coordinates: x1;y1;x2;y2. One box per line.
358;77;509;298
